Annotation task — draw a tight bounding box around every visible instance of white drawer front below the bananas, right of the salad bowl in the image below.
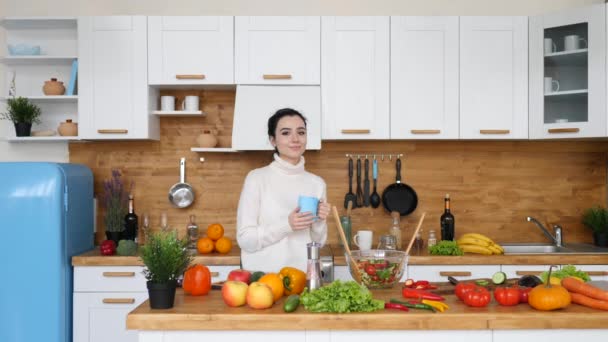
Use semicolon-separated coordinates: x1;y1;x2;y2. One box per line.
407;265;500;282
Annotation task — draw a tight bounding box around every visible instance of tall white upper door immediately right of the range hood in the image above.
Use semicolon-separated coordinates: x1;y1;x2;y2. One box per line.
321;17;389;139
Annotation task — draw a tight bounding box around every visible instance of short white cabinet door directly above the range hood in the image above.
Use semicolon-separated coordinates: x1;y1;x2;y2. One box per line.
234;16;321;85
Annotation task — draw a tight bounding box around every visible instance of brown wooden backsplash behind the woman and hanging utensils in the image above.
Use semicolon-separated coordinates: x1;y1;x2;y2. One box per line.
69;90;608;244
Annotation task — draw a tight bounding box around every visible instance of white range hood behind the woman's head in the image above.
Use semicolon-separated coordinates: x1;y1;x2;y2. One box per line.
232;85;321;151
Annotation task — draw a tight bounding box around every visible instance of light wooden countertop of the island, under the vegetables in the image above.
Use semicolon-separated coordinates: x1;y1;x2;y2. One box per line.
127;287;608;330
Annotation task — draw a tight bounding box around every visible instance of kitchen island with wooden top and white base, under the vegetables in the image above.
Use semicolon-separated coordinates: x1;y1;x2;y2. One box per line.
127;287;608;342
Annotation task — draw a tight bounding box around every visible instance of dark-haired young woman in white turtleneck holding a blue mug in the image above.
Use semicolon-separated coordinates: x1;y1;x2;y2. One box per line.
236;108;331;272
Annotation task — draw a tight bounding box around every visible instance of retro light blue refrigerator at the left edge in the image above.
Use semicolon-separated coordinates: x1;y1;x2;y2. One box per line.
0;162;93;342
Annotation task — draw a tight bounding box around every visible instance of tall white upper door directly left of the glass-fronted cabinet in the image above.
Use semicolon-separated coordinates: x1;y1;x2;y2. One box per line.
460;17;528;139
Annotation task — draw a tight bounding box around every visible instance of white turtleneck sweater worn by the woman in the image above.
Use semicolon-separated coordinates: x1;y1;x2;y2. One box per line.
236;154;327;272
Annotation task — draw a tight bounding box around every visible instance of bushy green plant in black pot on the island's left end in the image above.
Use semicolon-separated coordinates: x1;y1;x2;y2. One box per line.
141;231;192;309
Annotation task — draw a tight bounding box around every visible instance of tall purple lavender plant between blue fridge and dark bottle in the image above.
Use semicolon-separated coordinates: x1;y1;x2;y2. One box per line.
102;170;133;246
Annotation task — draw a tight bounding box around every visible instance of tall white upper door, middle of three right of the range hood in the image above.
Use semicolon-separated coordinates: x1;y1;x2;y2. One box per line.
390;17;459;139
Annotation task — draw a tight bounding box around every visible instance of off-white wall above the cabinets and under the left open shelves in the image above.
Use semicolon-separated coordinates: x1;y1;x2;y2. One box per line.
0;0;604;161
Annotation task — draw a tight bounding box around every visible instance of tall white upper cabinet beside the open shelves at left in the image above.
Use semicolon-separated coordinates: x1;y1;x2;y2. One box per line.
78;16;160;140
